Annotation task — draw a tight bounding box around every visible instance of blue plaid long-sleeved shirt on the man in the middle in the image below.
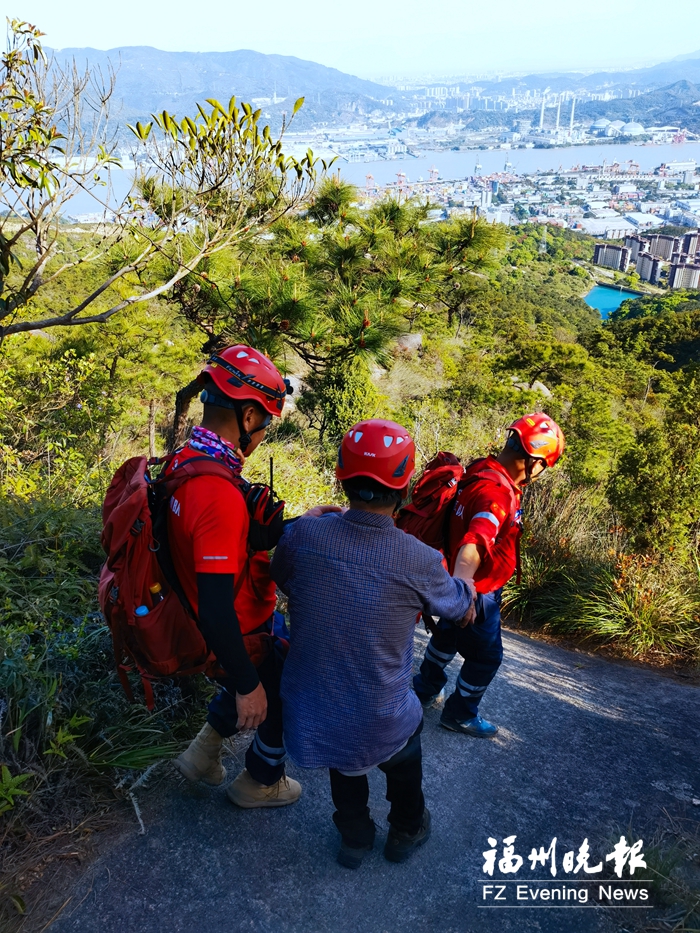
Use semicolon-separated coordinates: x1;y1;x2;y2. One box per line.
271;509;471;771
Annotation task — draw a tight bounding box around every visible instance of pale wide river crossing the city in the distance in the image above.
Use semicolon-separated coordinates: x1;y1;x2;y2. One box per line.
61;142;700;215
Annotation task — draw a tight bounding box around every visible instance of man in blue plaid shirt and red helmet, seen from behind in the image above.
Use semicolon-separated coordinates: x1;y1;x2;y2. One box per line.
271;420;474;868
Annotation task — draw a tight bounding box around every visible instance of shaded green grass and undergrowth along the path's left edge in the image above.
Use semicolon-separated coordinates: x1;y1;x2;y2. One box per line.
0;498;211;929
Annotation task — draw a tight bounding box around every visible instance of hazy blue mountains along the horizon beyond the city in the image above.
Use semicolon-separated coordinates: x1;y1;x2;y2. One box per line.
53;46;700;132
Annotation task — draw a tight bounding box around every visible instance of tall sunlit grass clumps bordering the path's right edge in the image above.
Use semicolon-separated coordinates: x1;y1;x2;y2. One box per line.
504;479;700;664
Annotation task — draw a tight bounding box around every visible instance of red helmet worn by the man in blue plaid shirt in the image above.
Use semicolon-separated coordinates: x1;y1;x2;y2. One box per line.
335;418;416;489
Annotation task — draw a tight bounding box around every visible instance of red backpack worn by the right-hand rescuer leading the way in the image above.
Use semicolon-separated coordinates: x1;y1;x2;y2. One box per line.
396;450;517;559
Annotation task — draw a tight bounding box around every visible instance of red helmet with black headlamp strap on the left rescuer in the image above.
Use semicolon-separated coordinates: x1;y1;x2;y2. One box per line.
198;344;291;418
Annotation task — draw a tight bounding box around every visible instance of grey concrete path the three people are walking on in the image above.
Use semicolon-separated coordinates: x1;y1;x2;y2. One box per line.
51;633;700;933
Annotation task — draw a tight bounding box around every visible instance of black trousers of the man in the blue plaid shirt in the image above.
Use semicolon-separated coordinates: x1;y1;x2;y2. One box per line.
330;720;425;849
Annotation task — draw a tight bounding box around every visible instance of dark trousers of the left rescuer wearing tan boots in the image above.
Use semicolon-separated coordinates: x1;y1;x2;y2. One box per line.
207;651;287;787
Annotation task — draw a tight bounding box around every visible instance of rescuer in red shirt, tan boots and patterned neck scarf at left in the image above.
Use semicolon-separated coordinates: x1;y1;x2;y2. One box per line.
168;345;332;808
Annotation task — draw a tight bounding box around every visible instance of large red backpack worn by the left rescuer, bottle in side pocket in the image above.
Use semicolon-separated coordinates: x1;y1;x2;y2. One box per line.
98;455;284;709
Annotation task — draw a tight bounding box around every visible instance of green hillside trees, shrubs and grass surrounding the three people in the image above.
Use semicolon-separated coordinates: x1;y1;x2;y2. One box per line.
0;191;700;916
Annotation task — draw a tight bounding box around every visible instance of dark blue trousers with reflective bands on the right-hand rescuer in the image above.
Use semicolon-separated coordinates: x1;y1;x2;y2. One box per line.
413;590;503;721
